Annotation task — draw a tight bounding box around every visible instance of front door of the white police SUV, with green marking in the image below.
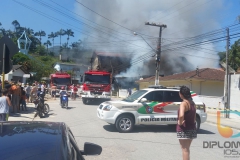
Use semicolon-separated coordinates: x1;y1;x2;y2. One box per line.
138;90;165;125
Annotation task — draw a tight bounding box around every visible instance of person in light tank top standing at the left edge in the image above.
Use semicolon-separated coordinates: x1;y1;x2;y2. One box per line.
0;88;12;121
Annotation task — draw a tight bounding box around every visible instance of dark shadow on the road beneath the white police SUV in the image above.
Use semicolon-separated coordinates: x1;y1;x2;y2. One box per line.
103;124;215;134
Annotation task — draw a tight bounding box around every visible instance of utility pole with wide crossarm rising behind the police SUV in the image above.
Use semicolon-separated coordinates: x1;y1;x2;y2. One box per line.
145;22;167;85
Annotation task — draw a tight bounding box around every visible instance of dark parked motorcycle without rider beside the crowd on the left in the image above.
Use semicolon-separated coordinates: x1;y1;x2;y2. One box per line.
33;95;50;118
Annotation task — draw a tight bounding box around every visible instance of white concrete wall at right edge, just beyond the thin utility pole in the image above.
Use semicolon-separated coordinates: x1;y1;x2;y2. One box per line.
230;74;240;110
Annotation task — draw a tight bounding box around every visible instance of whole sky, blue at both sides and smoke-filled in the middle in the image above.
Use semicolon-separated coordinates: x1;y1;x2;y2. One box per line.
0;0;240;75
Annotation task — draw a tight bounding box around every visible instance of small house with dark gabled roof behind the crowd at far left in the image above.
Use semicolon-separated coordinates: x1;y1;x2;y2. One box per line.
1;65;31;83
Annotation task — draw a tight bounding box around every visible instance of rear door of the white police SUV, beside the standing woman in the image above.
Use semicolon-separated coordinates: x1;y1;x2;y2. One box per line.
163;90;182;124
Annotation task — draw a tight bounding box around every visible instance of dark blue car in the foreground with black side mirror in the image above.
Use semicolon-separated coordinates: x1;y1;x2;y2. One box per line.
0;121;102;160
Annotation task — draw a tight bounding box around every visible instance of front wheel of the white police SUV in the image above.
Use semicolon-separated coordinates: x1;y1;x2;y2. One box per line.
115;115;134;133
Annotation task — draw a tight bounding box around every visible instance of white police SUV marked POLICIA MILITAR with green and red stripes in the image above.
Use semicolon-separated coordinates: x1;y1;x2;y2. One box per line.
97;86;207;132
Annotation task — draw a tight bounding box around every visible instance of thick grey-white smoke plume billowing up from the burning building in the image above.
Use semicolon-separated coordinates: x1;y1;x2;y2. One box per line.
75;0;223;77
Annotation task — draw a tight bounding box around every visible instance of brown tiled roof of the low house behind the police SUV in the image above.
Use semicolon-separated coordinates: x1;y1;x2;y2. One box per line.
137;68;225;97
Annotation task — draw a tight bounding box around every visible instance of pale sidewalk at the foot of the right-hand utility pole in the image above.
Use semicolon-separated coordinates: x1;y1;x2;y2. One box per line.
206;109;240;130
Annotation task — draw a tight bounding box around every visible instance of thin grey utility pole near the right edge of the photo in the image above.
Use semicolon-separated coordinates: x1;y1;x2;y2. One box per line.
224;28;230;118
